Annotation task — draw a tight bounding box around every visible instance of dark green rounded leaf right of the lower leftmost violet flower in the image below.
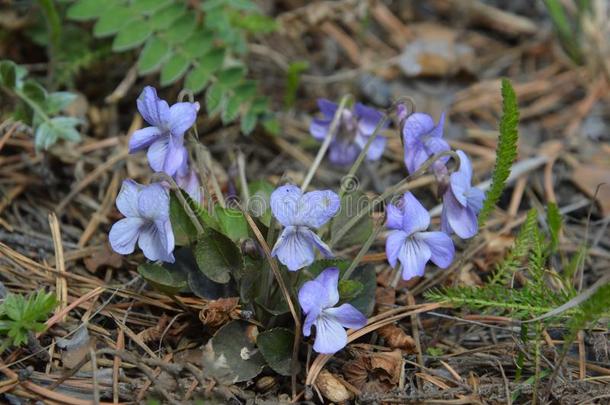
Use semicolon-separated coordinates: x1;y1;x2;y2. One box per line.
194;228;244;284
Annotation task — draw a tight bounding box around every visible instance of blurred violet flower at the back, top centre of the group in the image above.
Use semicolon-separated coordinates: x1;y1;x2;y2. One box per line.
309;99;389;166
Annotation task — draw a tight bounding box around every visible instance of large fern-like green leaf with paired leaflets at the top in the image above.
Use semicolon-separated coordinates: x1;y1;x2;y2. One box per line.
67;0;275;134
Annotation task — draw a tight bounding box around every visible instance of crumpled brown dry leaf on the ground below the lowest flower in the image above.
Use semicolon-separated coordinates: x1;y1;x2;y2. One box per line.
344;349;403;393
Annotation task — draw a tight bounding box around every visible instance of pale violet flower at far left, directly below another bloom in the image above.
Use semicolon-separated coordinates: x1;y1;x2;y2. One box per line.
108;179;174;263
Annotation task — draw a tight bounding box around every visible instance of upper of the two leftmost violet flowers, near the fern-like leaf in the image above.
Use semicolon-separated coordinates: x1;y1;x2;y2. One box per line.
129;86;199;176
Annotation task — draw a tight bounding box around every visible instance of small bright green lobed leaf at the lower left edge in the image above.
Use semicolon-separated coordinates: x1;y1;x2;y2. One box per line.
0;290;57;352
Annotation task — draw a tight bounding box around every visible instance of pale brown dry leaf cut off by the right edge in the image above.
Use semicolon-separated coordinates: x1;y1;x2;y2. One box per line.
572;160;610;217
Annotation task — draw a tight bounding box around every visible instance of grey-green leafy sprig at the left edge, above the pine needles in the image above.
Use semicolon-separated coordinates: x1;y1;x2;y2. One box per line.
0;60;80;150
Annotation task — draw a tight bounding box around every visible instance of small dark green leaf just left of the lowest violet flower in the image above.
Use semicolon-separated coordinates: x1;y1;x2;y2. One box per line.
256;328;294;376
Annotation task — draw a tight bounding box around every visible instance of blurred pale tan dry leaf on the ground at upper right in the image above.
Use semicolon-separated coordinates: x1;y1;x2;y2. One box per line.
399;23;475;77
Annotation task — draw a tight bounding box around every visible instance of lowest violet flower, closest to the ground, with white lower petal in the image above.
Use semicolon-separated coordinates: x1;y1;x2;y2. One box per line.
299;267;367;354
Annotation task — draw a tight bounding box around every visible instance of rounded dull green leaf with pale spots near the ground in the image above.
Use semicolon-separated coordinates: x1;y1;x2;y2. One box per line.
203;321;265;384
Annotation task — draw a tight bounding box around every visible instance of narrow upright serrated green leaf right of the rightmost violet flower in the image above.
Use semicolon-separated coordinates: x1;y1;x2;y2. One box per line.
479;79;519;227
